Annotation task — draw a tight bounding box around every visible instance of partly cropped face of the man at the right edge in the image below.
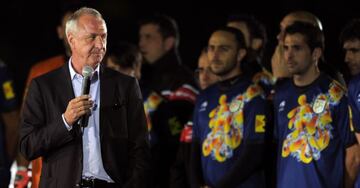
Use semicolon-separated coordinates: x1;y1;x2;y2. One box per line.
343;39;360;76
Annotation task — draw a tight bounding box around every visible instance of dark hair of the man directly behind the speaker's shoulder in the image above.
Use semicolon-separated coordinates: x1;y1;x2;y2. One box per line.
108;42;141;68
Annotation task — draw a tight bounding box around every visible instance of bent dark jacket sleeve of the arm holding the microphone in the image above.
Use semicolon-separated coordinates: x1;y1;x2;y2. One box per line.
20;79;79;160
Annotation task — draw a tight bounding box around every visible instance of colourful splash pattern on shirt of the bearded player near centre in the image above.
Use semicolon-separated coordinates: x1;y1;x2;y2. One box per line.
202;85;263;162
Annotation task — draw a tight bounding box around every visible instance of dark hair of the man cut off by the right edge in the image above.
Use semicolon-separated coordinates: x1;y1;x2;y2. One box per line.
340;19;360;44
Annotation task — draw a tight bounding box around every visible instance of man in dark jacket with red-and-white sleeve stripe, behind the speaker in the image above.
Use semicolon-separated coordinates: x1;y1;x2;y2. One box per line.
139;15;197;188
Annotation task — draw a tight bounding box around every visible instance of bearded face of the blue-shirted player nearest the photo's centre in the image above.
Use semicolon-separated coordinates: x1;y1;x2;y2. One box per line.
208;31;240;76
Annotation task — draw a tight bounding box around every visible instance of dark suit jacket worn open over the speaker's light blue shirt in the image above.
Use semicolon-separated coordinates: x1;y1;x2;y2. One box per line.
20;64;150;188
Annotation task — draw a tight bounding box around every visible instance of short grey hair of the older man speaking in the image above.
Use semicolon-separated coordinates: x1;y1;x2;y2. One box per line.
65;7;105;36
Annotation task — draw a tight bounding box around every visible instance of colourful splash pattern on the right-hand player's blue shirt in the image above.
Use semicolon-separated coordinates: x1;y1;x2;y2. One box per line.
282;82;344;164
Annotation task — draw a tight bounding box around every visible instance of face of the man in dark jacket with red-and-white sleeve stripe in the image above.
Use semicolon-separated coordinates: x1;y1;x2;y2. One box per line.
139;24;168;64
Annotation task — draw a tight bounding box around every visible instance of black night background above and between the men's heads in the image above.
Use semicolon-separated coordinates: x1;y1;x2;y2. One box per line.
0;0;360;101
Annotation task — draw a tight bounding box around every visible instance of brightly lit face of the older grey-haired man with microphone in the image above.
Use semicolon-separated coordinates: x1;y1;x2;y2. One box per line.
68;15;107;68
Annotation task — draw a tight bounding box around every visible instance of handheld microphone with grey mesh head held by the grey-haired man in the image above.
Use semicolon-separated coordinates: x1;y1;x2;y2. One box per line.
78;65;94;127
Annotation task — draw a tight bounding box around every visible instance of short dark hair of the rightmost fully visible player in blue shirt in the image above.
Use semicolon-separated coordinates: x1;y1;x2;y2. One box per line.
285;21;325;51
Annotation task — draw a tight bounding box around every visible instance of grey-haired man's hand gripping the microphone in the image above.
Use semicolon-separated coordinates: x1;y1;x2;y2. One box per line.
64;95;94;126
